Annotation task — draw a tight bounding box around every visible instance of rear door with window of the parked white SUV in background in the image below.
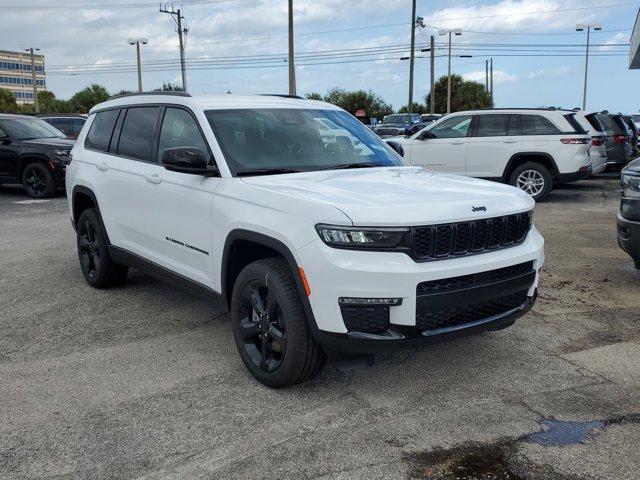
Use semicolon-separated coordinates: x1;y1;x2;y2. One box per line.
466;113;522;178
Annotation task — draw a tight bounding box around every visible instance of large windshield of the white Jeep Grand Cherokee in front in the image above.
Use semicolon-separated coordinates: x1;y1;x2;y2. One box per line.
205;108;403;176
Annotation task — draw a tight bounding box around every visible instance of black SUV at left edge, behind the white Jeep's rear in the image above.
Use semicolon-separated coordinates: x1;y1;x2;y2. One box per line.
0;114;74;198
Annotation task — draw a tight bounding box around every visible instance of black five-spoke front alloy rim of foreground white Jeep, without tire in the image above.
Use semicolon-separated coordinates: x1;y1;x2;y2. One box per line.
239;280;287;372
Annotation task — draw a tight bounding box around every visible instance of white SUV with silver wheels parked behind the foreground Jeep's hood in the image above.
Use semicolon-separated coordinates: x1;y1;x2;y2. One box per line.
389;109;592;200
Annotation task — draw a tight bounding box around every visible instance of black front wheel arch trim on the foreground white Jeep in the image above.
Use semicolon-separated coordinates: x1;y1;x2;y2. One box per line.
220;229;315;327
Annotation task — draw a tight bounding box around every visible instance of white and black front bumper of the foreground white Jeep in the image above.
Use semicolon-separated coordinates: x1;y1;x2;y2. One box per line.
296;227;544;352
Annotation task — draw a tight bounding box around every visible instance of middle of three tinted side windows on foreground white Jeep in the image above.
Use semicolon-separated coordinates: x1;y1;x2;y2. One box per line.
118;107;160;160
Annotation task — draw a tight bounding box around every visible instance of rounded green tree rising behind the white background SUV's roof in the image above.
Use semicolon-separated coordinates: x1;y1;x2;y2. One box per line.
426;75;493;113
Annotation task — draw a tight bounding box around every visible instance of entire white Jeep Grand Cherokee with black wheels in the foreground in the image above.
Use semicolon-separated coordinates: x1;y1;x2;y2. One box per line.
66;93;544;387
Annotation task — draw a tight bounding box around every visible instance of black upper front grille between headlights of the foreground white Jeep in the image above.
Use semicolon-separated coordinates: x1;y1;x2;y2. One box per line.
412;212;533;261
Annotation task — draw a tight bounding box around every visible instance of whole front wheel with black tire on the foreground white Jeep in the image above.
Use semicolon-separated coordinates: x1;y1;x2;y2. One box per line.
231;258;326;388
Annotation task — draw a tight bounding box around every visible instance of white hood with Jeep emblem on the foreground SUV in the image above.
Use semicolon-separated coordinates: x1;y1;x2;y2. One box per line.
243;167;535;226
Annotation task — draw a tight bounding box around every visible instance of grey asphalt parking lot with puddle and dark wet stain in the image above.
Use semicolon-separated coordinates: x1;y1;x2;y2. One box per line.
0;174;640;480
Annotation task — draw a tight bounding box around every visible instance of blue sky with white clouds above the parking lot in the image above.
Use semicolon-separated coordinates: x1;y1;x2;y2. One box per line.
5;0;640;112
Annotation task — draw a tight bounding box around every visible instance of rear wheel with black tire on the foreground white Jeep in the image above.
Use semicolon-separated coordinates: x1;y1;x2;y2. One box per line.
76;208;129;288
